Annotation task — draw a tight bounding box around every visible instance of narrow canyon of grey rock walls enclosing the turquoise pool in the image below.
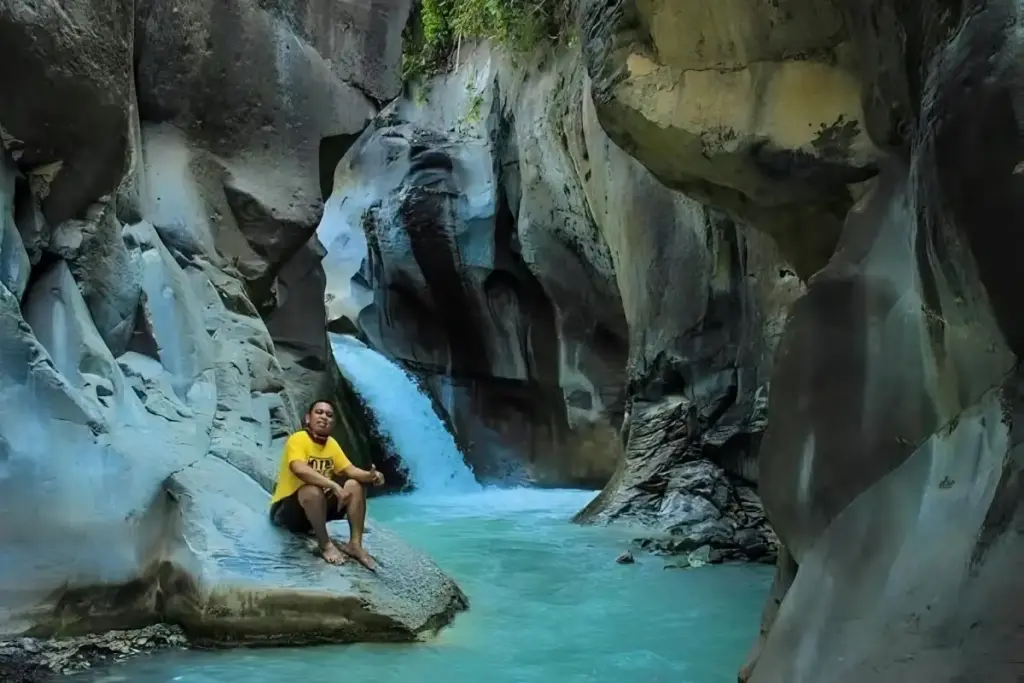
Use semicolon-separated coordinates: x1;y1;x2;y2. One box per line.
0;0;1024;683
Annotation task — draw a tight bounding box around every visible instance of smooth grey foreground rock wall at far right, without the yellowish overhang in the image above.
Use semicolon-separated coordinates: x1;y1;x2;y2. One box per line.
744;0;1024;683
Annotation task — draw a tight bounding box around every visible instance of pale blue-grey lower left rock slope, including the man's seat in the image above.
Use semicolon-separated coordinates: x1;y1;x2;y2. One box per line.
0;215;467;644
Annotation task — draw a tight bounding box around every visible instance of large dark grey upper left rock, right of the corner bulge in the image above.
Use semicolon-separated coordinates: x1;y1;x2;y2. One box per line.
126;0;399;280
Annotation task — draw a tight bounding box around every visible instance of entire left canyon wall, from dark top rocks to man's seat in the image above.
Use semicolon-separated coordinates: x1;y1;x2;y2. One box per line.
0;0;466;643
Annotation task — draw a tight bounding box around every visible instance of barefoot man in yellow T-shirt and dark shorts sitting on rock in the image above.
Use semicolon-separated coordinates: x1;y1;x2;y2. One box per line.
270;400;384;570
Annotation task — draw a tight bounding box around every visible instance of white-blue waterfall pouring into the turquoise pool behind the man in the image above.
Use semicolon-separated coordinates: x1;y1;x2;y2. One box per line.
331;334;480;494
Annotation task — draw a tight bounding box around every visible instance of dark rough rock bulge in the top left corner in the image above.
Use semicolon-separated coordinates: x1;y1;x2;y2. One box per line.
0;0;134;224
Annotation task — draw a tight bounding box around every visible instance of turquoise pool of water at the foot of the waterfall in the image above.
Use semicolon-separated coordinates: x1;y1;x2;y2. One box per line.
79;489;771;683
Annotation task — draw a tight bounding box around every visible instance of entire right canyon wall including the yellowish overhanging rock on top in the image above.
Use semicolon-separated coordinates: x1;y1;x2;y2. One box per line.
584;0;1024;683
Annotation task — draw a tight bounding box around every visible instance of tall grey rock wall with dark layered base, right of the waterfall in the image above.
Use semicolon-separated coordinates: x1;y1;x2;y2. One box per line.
542;54;803;548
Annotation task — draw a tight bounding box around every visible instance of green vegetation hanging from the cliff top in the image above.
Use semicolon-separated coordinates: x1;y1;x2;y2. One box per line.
401;0;574;79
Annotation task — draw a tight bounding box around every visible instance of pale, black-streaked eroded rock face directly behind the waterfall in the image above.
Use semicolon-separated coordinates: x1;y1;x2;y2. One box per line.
318;49;626;486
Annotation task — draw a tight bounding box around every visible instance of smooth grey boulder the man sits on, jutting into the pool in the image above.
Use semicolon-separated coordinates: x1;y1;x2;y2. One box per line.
161;458;468;644
